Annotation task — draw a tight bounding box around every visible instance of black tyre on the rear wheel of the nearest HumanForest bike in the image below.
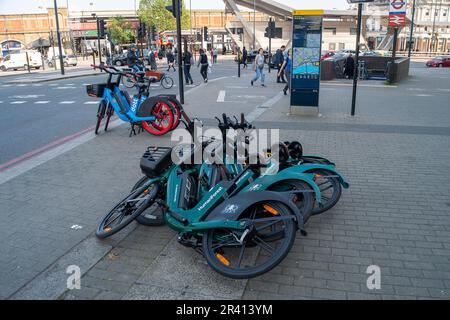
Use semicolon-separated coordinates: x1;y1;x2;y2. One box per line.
202;201;296;279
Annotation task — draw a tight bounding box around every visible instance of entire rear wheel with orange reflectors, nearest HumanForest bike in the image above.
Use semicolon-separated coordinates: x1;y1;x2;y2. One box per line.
202;201;296;279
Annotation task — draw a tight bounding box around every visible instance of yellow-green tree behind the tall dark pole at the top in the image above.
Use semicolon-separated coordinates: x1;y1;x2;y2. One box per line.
139;0;189;31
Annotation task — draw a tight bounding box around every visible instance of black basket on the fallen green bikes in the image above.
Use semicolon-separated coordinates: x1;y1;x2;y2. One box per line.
141;146;172;177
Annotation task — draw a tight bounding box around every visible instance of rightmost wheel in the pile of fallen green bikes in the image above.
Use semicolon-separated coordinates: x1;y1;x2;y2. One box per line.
307;169;342;216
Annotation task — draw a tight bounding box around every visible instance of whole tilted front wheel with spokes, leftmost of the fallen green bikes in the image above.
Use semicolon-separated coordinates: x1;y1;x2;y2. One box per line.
95;184;158;239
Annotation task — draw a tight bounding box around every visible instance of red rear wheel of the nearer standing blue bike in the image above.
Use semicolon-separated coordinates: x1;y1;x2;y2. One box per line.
142;101;174;136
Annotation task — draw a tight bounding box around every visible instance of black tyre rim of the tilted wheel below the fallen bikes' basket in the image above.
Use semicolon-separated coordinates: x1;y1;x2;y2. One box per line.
95;184;158;239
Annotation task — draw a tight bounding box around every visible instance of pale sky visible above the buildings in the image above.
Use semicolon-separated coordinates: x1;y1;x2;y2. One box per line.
0;0;348;15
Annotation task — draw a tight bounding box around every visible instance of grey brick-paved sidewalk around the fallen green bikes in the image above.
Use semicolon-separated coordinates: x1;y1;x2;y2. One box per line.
0;68;450;299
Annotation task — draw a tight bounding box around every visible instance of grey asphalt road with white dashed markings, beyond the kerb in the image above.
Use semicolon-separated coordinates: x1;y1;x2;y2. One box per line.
0;61;237;168
